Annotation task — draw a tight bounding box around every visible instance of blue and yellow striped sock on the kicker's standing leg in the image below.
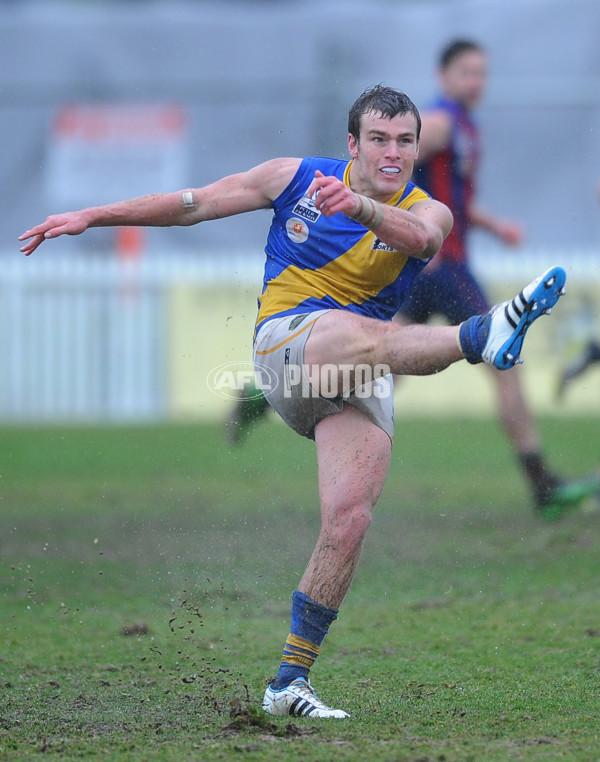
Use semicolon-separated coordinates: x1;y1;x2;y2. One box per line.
271;590;338;691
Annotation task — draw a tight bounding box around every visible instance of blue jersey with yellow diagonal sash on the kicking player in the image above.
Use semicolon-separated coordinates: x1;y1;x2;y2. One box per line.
256;157;429;330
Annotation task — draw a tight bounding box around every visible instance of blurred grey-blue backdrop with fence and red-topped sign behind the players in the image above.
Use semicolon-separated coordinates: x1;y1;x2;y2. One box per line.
0;0;600;422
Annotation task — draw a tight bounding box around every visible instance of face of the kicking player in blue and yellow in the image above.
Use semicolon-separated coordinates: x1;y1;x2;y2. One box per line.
348;112;418;201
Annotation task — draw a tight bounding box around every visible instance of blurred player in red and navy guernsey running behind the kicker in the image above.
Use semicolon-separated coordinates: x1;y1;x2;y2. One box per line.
396;40;600;518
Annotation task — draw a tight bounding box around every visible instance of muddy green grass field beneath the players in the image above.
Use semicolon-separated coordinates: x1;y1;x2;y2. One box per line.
0;418;600;762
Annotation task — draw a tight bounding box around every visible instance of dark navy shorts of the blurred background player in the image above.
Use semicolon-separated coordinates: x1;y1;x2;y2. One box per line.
398;262;490;325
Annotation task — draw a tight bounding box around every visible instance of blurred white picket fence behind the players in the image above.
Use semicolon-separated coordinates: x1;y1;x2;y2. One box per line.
0;251;600;422
